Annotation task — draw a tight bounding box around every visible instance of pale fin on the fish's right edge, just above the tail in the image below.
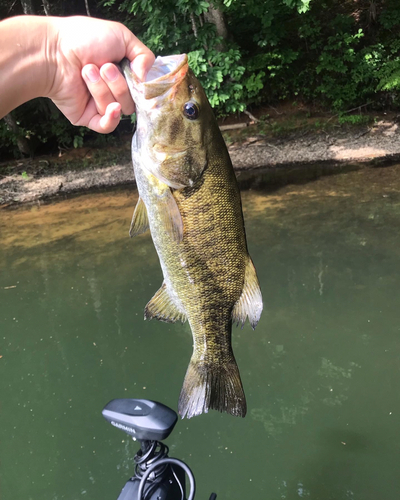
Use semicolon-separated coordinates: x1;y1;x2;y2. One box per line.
232;257;263;330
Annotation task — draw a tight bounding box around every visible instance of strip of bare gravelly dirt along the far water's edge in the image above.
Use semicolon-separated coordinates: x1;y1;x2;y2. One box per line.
0;117;400;206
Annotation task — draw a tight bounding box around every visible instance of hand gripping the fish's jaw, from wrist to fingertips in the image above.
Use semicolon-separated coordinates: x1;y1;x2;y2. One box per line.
47;16;154;133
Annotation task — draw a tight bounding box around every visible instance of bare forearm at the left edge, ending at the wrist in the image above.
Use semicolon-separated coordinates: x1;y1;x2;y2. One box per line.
0;16;56;118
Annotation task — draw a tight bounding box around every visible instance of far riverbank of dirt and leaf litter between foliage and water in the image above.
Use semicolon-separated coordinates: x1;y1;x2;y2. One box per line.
0;112;400;207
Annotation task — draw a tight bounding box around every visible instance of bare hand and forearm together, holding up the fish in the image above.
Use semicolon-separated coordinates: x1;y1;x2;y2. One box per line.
0;16;154;134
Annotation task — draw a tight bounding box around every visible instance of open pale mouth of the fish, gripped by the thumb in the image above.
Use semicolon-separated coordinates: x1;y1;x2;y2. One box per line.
121;54;189;101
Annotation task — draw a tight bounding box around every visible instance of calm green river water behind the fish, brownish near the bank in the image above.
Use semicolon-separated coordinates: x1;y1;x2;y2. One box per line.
0;166;400;500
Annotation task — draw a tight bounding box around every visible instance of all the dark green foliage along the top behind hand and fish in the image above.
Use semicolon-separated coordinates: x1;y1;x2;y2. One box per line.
0;0;400;156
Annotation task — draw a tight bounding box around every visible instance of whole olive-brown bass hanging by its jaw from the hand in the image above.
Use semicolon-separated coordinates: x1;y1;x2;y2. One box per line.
121;54;263;418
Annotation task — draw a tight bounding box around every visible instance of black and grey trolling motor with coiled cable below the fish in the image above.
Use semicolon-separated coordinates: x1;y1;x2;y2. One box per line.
102;399;217;500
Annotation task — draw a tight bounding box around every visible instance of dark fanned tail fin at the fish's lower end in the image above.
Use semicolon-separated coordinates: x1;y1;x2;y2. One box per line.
178;358;247;418
